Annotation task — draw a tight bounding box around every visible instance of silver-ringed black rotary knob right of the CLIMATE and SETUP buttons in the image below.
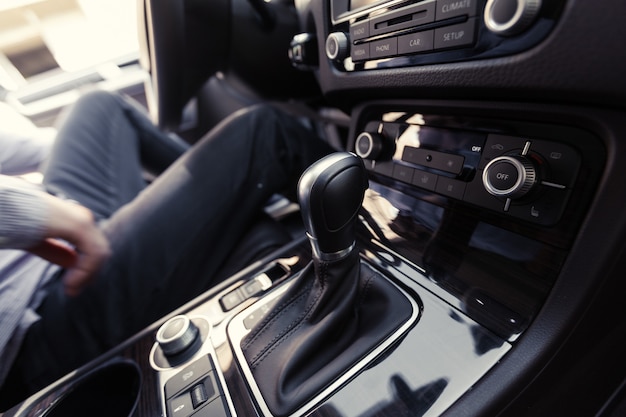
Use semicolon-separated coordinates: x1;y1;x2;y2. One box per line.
485;0;541;36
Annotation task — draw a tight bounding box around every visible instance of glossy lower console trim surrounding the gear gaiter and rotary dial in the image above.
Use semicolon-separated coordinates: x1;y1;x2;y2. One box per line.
6;239;511;417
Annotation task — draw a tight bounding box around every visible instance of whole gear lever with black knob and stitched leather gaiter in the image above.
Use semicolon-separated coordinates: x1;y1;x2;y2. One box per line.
241;152;414;416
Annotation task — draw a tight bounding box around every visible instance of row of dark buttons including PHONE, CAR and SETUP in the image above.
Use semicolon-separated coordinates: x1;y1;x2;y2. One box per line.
350;18;476;61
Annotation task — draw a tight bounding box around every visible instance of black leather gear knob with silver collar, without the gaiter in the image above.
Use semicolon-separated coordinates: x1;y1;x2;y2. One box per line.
298;152;368;261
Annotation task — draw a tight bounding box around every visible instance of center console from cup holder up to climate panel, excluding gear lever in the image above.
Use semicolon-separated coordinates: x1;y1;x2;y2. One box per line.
7;97;605;417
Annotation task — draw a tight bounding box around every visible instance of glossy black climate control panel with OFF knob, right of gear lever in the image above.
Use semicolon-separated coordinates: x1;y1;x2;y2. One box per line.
350;102;604;341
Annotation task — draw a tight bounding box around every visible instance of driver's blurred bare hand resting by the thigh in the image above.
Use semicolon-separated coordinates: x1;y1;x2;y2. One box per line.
29;194;110;296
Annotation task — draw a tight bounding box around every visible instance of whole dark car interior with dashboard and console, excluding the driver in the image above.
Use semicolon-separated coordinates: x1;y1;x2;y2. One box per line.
0;0;626;417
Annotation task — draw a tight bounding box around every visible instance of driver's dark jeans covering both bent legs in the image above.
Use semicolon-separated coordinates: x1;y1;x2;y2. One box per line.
0;93;330;406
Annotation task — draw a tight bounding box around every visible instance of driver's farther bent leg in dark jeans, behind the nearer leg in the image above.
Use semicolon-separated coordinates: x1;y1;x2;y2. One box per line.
44;91;187;219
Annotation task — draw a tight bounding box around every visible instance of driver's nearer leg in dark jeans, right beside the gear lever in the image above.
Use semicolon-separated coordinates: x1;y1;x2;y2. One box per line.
8;102;331;398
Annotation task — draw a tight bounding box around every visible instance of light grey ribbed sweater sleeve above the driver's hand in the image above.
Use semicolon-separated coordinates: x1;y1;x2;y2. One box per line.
0;175;48;249
